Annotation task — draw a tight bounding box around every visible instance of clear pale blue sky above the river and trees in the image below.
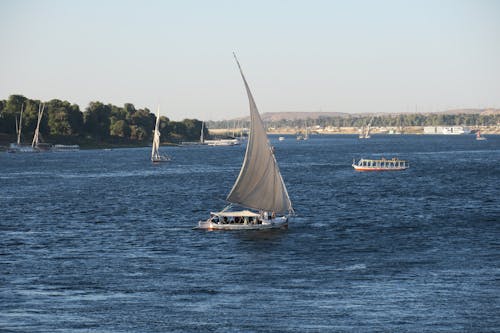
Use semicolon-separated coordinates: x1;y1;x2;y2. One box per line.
0;0;500;120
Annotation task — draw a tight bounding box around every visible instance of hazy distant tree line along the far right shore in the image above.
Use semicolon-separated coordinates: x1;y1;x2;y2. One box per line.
208;113;500;130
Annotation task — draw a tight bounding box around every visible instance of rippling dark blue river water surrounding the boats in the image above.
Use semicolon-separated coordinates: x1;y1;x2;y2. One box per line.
0;135;500;332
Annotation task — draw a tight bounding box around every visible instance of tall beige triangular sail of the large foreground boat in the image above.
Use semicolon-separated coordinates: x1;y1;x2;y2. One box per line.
227;55;293;213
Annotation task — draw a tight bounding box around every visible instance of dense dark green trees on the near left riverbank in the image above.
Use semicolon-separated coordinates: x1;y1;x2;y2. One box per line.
0;95;207;144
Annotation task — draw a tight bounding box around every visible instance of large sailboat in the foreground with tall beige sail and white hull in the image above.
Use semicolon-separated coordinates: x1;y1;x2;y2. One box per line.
196;55;294;230
